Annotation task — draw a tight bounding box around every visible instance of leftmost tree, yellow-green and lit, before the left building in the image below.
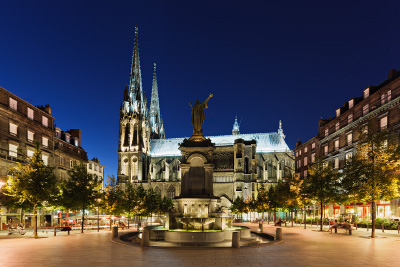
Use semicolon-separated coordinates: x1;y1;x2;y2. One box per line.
4;142;60;238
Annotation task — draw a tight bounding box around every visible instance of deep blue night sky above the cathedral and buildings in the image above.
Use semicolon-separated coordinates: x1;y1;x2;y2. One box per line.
0;1;400;180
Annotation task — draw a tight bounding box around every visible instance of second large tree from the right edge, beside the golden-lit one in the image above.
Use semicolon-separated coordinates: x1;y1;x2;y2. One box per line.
305;158;339;231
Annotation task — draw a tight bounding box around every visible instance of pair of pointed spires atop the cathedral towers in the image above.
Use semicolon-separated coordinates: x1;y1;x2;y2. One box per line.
121;27;165;139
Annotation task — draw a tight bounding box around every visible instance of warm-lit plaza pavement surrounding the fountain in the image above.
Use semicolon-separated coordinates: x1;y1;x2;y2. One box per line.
0;224;400;267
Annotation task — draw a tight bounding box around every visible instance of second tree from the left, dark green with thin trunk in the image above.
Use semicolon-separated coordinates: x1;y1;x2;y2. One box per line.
60;162;102;233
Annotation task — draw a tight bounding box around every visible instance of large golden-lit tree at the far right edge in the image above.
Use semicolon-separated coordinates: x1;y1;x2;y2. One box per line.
342;132;399;238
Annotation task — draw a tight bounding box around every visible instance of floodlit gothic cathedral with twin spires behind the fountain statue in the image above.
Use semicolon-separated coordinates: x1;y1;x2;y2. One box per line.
117;29;294;207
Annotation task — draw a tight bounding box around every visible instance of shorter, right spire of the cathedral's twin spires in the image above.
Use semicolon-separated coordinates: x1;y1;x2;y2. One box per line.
150;62;164;139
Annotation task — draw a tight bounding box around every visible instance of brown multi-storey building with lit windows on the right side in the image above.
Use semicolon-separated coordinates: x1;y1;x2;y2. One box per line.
294;70;400;220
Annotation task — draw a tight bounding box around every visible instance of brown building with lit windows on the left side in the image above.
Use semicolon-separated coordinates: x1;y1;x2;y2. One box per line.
0;87;87;229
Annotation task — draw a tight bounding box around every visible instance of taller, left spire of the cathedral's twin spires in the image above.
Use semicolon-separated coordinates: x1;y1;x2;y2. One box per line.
129;27;143;113
